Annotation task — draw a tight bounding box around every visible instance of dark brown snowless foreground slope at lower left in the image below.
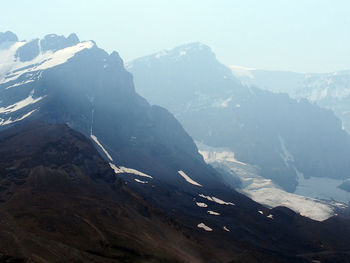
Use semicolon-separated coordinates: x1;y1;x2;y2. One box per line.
0;122;208;262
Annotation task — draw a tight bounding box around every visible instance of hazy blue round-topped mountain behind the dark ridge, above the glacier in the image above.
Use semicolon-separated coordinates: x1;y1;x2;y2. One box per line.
127;43;350;203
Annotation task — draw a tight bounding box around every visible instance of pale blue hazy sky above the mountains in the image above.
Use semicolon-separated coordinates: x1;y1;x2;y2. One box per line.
0;0;350;73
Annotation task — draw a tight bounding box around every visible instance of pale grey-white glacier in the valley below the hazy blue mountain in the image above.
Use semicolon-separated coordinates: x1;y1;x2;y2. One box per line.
197;143;350;221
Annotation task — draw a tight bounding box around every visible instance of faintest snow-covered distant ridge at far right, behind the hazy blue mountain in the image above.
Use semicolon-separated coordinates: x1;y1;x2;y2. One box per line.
230;66;350;133
